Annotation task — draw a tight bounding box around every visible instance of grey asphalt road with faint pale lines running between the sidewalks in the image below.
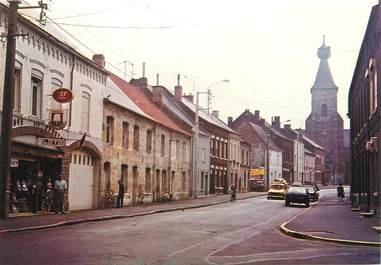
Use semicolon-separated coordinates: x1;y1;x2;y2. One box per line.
0;191;380;265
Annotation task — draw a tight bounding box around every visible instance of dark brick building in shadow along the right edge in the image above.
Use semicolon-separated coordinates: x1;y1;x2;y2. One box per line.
348;3;381;216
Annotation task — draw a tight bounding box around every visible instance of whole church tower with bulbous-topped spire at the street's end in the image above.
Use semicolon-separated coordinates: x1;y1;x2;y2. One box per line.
306;37;344;183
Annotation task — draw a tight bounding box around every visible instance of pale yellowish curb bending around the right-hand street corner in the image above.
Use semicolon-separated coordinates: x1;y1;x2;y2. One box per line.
279;204;381;247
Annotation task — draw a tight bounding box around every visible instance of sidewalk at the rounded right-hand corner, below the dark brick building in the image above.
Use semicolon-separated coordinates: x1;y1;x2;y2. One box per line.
281;193;381;246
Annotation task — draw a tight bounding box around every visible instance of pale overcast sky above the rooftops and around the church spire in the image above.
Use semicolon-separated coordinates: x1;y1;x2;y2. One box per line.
16;0;378;128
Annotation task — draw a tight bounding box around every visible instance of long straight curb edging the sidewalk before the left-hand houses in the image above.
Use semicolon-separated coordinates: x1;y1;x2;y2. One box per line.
0;194;266;235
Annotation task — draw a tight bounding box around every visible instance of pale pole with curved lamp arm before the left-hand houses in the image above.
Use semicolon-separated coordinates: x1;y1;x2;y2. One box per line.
191;79;229;198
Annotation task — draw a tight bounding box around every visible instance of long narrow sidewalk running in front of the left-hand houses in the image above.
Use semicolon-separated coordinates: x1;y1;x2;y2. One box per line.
0;192;267;234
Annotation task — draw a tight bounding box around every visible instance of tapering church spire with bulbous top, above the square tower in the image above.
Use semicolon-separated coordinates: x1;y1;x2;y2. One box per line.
312;35;337;90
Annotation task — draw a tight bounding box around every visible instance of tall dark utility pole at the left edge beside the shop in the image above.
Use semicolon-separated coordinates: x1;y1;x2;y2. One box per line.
0;0;47;219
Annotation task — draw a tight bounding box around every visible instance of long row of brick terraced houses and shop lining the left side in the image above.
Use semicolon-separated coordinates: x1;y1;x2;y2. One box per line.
0;4;324;212
